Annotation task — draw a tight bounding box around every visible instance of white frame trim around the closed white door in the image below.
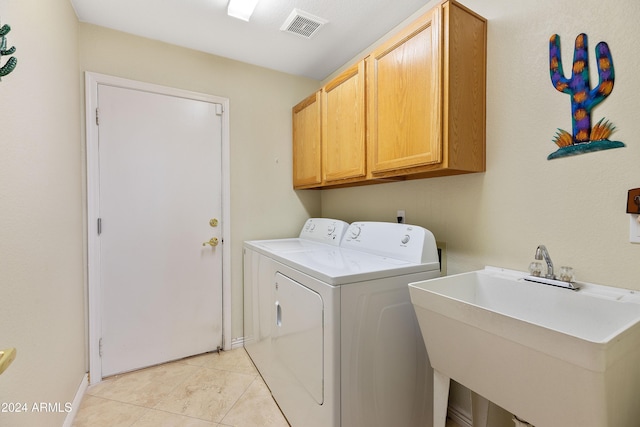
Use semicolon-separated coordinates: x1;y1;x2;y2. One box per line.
85;72;231;384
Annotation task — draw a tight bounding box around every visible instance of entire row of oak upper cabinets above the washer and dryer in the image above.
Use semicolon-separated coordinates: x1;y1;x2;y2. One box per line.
293;0;487;188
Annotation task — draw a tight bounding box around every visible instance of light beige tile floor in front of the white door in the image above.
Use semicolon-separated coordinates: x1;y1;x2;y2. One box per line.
73;349;458;427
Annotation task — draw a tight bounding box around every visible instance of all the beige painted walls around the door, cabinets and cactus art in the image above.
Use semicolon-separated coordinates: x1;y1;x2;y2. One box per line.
0;0;640;427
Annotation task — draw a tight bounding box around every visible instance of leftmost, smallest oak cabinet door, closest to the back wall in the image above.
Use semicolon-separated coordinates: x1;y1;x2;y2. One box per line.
293;91;322;188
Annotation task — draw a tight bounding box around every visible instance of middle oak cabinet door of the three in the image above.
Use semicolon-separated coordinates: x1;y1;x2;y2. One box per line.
322;61;366;184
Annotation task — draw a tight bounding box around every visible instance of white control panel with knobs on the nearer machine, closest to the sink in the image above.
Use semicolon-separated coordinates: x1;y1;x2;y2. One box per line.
340;221;438;263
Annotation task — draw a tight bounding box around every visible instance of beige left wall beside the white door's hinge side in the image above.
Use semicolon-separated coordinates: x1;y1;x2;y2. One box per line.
0;0;86;427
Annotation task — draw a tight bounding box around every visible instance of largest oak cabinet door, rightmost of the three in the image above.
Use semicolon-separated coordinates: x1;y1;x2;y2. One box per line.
367;8;442;176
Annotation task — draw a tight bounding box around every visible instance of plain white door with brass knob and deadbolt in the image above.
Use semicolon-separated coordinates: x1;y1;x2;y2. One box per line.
97;84;222;376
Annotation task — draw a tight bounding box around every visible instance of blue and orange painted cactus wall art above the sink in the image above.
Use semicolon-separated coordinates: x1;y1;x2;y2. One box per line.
547;34;625;160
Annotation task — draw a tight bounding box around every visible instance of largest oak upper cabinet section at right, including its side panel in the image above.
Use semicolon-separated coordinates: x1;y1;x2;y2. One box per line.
367;1;486;178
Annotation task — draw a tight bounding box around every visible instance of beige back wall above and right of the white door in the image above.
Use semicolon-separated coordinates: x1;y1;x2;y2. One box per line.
79;24;320;339
